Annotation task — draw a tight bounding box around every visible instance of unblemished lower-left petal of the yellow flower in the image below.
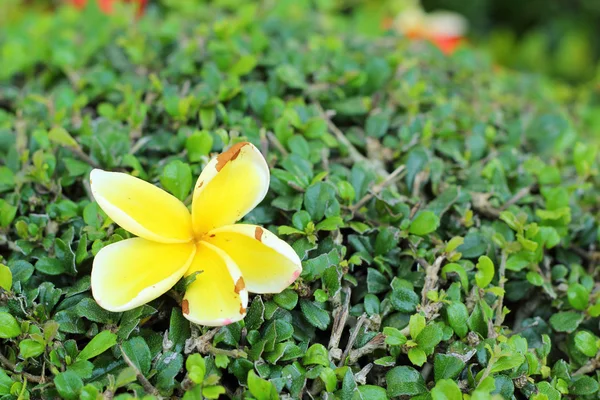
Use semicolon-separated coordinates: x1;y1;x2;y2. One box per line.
92;238;196;311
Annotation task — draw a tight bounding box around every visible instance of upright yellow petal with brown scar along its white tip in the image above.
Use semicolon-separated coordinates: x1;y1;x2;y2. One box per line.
192;142;269;235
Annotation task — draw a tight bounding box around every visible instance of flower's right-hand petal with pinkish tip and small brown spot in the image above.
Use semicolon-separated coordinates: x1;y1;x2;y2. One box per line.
206;224;302;293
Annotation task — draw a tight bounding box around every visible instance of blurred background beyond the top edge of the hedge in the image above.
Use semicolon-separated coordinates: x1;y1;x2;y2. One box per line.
0;0;600;85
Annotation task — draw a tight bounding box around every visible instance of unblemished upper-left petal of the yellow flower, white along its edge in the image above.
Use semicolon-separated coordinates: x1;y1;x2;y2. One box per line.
90;169;193;243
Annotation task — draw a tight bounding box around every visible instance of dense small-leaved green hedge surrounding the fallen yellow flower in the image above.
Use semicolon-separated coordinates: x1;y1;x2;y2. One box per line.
0;1;600;400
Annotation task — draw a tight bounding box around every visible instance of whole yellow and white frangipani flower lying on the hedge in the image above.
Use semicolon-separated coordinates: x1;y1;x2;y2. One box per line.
90;142;302;326
